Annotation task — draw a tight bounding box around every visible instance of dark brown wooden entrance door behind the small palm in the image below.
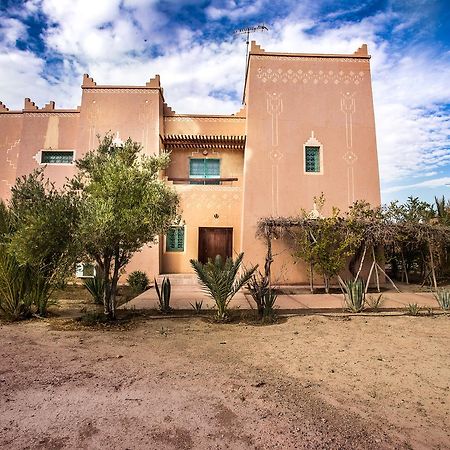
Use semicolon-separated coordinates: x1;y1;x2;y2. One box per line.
198;227;233;263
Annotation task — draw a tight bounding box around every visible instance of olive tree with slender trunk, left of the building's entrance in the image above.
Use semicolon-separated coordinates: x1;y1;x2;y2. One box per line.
72;134;178;318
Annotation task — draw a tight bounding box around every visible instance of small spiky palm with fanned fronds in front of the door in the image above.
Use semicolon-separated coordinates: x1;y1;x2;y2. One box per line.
190;253;258;321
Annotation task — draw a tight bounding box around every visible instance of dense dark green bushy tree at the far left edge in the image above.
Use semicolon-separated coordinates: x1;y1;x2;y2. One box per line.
1;169;79;316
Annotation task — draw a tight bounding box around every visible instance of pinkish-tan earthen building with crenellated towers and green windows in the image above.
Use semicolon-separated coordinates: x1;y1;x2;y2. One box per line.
0;42;380;283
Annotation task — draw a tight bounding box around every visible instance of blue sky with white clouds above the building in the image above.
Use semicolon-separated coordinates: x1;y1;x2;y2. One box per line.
0;0;450;203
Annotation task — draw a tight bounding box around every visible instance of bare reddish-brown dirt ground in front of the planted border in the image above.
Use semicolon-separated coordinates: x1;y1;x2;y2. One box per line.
0;314;450;449
